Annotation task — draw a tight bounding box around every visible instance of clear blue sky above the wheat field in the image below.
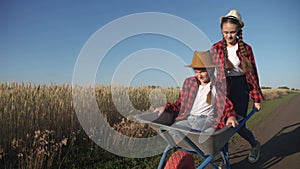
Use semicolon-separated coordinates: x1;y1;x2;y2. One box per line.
0;0;300;89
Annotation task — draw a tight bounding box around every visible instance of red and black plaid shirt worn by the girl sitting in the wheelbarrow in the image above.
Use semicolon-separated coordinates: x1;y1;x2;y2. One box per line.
165;76;237;129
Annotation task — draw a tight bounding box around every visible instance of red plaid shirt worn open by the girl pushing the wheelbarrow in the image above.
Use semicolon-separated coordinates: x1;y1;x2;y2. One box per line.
210;40;263;103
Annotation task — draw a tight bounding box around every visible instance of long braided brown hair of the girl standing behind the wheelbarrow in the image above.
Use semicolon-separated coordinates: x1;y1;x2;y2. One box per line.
221;18;252;74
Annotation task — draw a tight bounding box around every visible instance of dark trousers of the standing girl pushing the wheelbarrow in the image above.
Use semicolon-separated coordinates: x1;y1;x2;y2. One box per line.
227;76;256;146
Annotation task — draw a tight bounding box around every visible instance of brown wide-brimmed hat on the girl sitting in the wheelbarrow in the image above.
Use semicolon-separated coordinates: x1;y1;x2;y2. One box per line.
185;51;216;68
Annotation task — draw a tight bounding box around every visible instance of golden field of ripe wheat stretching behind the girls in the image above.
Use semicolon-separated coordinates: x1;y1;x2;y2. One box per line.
0;82;290;169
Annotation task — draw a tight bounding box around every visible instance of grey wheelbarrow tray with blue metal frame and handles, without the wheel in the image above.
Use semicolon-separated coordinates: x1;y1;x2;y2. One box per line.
137;108;257;169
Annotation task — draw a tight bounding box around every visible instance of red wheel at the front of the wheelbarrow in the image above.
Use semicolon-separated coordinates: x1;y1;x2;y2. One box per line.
165;150;196;169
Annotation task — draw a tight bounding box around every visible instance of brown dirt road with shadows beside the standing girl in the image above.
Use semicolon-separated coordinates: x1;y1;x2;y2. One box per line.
229;95;300;169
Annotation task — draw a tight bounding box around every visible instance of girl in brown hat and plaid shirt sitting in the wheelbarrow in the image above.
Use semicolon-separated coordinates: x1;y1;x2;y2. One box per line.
154;51;238;131
